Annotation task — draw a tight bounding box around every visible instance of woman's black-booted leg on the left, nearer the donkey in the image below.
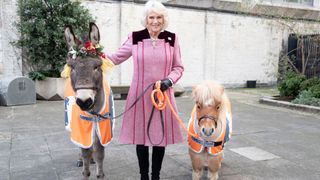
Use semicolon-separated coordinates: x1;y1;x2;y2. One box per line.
136;145;149;180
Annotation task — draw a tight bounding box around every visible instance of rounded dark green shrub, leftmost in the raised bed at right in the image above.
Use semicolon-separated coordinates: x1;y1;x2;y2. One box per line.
278;71;306;98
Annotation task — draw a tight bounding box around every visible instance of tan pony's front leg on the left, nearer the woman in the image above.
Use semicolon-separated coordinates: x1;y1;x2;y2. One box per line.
189;149;203;180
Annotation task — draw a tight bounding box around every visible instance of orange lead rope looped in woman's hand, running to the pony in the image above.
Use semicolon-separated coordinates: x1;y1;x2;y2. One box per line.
151;81;199;138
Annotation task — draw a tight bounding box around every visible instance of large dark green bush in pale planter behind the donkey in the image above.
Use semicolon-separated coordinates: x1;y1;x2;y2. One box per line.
15;0;93;100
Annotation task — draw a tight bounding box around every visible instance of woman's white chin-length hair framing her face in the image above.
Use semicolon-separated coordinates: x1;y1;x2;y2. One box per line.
141;0;169;30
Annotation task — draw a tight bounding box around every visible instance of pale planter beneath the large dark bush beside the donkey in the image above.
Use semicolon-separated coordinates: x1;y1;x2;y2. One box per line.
36;77;66;101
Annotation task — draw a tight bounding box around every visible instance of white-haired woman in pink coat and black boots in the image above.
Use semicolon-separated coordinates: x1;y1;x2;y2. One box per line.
108;0;184;179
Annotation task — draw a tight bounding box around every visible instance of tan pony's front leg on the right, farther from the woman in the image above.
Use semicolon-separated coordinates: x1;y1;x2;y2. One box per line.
208;152;223;180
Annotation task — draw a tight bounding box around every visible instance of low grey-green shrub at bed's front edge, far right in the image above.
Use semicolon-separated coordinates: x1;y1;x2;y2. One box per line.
292;90;320;106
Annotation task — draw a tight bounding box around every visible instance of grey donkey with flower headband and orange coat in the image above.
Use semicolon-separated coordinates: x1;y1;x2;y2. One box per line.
64;23;114;179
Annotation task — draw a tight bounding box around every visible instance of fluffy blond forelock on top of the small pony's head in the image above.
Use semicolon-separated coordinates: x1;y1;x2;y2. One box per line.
192;81;223;106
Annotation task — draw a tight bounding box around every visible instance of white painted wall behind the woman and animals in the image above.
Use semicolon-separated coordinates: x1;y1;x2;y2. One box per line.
0;0;320;87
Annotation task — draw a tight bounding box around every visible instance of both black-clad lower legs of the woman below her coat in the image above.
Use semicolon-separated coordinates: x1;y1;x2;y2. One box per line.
136;145;165;180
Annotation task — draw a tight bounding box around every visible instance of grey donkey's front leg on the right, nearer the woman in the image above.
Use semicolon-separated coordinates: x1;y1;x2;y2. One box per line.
93;136;104;179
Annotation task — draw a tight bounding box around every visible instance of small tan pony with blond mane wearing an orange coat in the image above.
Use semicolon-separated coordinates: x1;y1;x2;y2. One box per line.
188;81;232;180
